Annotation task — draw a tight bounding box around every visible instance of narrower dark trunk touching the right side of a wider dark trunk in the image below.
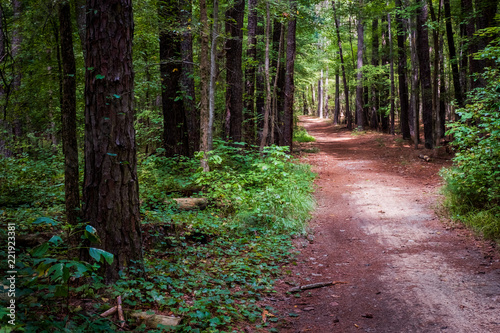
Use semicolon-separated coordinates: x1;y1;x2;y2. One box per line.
181;0;200;156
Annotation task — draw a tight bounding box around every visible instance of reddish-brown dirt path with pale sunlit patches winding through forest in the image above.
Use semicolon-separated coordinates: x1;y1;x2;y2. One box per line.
265;117;500;333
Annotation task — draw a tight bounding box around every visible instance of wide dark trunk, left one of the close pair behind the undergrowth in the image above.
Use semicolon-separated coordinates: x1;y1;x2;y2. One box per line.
158;0;189;157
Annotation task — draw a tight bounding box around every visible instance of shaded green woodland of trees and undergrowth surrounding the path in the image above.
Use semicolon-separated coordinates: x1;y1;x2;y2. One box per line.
0;0;500;331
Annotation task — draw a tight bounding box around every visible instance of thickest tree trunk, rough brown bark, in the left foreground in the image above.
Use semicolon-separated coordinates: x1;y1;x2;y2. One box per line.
83;0;143;283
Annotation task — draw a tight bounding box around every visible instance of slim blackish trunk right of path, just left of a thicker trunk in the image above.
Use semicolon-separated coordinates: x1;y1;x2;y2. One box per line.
396;0;411;140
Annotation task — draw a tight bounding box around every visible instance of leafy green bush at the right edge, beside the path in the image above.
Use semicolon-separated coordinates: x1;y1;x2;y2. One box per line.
442;49;500;237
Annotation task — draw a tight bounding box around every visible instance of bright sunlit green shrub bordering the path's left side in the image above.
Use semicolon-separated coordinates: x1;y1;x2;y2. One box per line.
195;142;314;233
